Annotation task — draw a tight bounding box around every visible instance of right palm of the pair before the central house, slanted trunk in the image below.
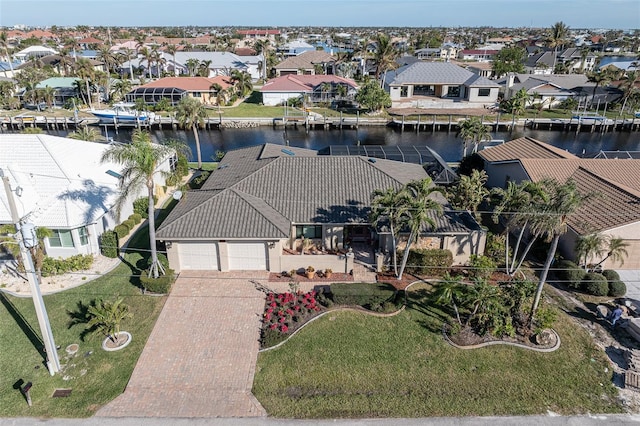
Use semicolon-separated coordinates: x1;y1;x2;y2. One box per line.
398;178;442;280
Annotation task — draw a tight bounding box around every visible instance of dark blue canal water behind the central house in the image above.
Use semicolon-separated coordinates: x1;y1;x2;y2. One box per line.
43;126;640;162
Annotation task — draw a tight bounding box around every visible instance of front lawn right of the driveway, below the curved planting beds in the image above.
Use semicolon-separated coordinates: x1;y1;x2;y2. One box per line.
253;282;622;418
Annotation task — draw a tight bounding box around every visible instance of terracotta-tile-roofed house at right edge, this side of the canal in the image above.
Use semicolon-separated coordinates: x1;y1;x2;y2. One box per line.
478;137;640;269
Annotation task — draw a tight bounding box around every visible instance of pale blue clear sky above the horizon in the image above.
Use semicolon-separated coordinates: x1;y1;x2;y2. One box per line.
0;0;640;29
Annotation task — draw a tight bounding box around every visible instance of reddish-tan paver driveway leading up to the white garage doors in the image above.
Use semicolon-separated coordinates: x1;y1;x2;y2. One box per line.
96;271;267;417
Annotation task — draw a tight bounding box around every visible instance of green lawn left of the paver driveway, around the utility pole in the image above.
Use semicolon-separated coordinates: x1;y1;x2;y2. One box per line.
0;203;175;417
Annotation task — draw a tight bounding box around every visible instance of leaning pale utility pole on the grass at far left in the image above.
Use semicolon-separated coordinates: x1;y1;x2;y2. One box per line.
0;169;60;376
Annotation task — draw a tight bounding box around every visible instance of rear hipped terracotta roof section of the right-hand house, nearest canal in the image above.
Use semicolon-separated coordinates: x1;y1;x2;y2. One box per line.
478;137;578;162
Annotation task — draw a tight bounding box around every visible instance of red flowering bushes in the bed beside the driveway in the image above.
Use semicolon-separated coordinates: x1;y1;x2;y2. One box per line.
262;290;323;347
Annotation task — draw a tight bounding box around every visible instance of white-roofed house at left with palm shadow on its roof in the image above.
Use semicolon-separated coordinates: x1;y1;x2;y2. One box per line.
0;134;169;258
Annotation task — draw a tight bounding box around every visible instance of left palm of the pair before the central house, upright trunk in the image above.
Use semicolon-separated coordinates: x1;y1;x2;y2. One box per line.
370;188;405;276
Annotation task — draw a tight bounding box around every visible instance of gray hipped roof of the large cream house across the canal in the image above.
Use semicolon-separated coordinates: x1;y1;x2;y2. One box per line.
385;62;498;87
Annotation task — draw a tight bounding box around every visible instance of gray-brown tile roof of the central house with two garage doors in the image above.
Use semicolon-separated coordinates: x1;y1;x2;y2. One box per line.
157;145;444;239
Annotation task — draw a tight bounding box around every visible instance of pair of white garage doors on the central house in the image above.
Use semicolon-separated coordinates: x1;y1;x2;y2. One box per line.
179;242;267;271
